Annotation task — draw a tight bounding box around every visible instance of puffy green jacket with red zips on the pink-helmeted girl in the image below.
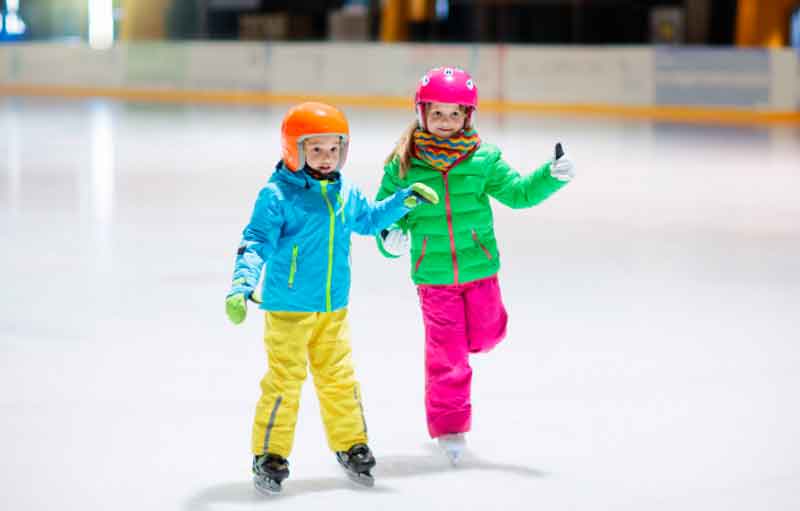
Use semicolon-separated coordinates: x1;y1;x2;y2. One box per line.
377;144;565;284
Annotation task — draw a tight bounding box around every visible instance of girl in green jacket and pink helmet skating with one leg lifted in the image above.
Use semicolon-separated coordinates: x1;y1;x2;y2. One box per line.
377;68;574;464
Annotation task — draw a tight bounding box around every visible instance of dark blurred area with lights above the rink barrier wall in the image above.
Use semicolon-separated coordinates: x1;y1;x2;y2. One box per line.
0;0;800;47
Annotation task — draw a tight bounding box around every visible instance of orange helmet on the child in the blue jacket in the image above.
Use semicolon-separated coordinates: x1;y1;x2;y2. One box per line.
281;102;350;172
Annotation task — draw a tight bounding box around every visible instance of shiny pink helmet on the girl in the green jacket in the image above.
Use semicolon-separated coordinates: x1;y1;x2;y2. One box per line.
414;67;478;128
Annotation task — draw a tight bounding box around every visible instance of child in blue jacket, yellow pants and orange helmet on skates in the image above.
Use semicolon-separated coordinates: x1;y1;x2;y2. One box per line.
225;103;438;493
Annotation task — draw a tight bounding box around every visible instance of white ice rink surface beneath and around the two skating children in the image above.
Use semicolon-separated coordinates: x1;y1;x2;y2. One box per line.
0;98;800;511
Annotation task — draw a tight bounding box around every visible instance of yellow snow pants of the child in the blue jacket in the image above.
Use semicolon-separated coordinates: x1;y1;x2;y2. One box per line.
252;309;367;458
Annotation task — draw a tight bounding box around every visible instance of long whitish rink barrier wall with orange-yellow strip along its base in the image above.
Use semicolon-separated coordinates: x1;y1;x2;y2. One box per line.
0;42;800;124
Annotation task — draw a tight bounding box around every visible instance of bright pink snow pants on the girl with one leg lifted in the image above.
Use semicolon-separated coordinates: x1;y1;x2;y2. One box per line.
417;275;508;438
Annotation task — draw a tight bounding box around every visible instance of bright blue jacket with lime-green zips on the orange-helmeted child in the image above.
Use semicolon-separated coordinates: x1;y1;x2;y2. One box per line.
230;163;411;312
